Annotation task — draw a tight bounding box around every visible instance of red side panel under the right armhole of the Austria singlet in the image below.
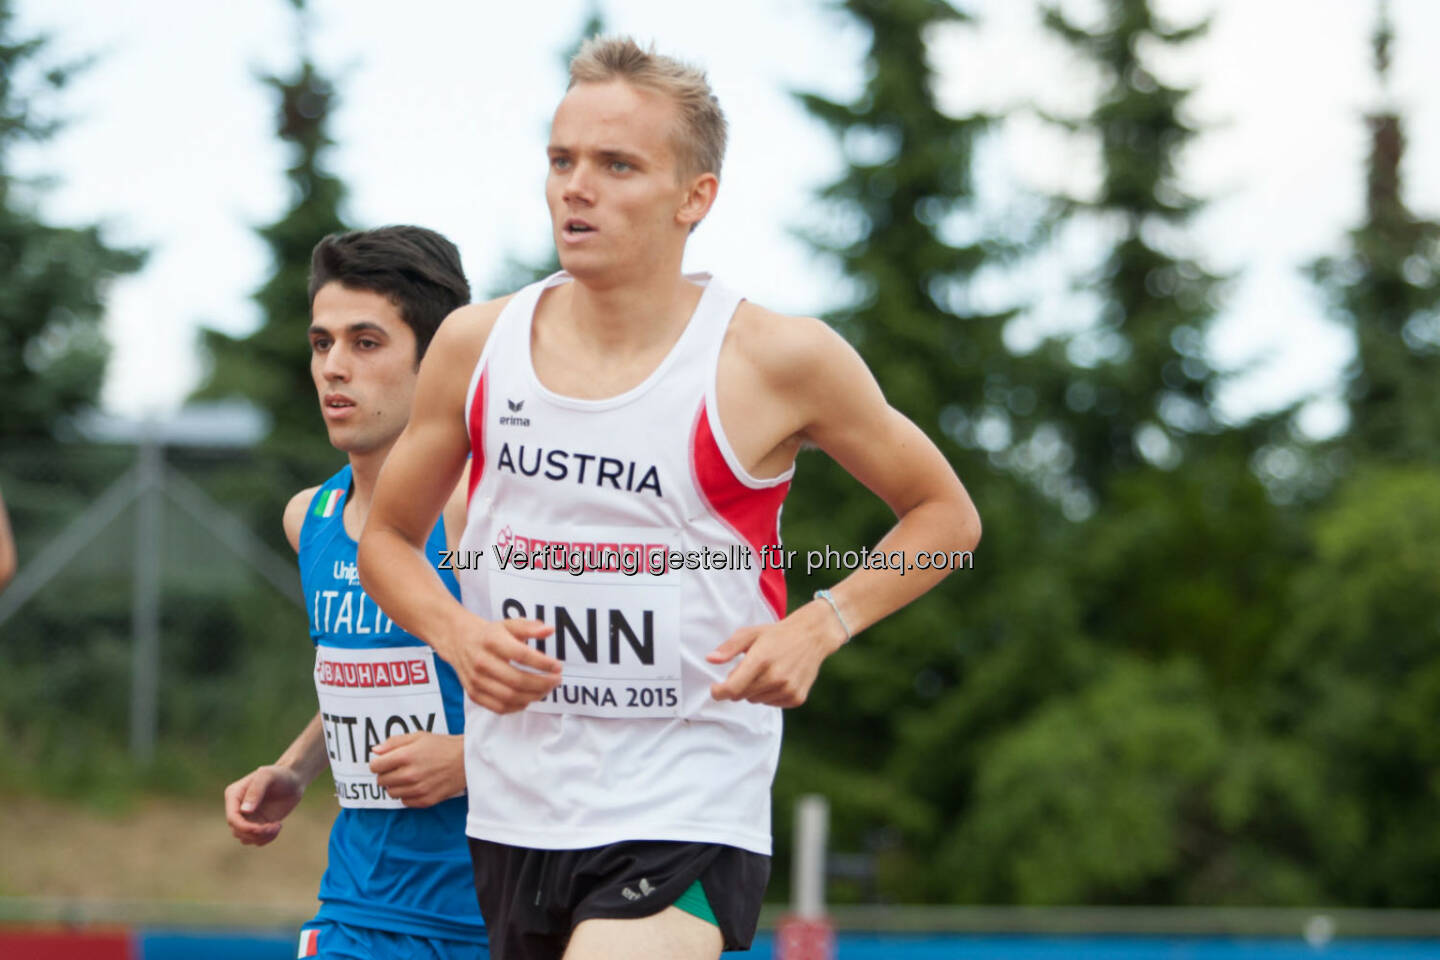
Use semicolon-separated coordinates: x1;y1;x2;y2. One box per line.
690;400;791;619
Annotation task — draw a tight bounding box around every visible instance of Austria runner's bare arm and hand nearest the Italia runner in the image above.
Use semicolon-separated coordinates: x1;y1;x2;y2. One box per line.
359;301;560;712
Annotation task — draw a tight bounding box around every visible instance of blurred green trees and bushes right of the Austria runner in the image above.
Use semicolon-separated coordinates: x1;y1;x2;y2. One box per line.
778;0;1440;905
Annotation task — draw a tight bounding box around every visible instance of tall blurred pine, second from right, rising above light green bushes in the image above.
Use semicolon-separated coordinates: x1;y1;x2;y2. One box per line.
1040;0;1296;689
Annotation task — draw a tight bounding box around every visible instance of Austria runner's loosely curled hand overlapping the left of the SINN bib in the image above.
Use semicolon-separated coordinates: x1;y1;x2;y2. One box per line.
435;613;560;714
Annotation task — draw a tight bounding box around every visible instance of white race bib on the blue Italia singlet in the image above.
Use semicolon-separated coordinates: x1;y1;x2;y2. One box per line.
315;646;449;809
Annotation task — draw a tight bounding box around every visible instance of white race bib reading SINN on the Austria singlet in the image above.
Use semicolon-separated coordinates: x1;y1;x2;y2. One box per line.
485;522;683;718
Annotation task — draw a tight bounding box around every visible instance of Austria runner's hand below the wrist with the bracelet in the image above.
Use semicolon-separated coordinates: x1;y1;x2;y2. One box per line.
706;603;845;707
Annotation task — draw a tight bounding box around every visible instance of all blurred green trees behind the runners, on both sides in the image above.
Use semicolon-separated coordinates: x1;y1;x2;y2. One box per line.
0;0;1440;907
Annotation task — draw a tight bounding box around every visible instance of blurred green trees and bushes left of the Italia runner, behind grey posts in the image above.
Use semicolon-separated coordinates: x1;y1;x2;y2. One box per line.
0;0;324;806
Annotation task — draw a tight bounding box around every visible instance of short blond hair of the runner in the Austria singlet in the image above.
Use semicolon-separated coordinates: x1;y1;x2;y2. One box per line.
570;36;726;177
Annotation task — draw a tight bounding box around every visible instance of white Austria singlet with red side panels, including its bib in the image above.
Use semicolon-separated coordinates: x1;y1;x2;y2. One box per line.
456;272;793;853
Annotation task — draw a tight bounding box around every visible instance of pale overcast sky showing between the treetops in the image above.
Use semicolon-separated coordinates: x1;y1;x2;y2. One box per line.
17;0;1440;440
